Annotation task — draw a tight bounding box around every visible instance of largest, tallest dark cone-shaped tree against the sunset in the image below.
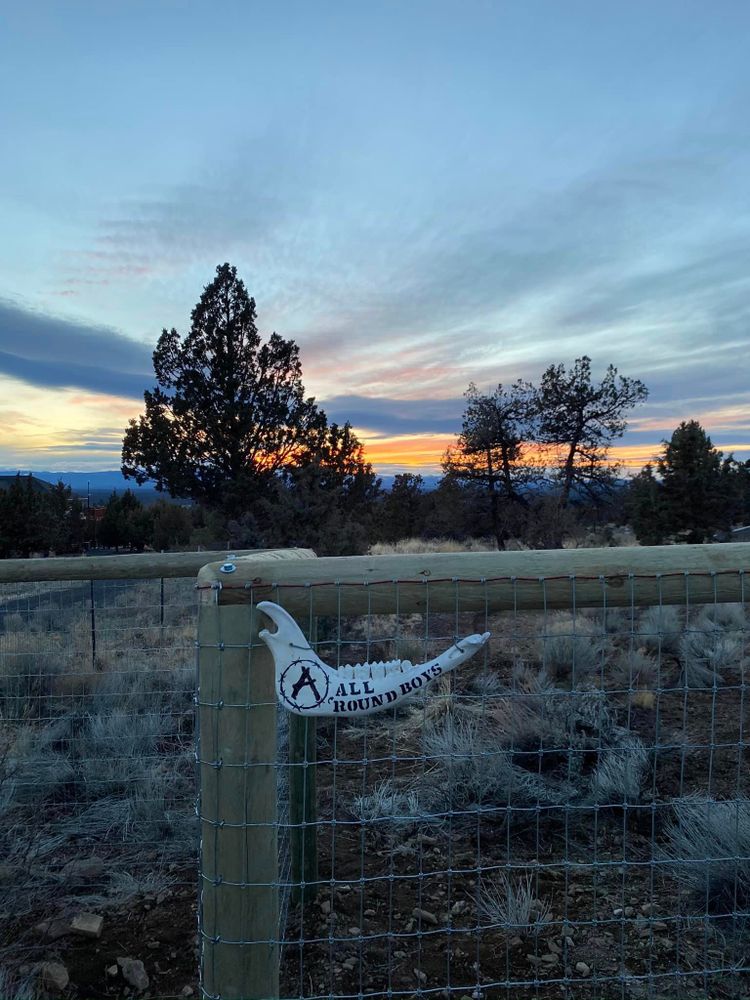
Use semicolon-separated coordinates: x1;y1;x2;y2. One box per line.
122;264;325;506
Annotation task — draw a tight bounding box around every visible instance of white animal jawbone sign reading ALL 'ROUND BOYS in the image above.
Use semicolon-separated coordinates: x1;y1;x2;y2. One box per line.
258;601;490;715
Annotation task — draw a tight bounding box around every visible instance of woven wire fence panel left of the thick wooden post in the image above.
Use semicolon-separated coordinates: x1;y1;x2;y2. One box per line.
0;579;198;1000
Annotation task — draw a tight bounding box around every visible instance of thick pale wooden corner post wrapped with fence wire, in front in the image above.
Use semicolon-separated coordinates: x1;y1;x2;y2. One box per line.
198;592;279;1000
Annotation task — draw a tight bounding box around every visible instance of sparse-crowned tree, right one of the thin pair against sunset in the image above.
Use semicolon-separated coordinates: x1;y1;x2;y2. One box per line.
538;355;648;507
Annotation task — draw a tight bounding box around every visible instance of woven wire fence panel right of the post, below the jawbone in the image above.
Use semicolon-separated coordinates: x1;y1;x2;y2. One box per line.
204;574;750;1000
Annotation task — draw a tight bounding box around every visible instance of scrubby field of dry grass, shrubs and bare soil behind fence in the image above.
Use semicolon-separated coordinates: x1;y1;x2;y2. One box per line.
0;552;750;1000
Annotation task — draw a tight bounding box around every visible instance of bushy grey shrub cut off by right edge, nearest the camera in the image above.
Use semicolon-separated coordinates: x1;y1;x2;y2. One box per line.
662;795;750;916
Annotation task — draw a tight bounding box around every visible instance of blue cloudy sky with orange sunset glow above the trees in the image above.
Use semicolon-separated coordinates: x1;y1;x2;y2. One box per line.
0;0;750;473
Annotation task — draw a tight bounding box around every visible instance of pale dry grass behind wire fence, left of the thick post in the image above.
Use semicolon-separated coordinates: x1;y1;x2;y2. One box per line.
0;581;197;968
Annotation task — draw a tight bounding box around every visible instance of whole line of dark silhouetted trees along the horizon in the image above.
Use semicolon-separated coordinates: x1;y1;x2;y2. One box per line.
0;264;750;555
